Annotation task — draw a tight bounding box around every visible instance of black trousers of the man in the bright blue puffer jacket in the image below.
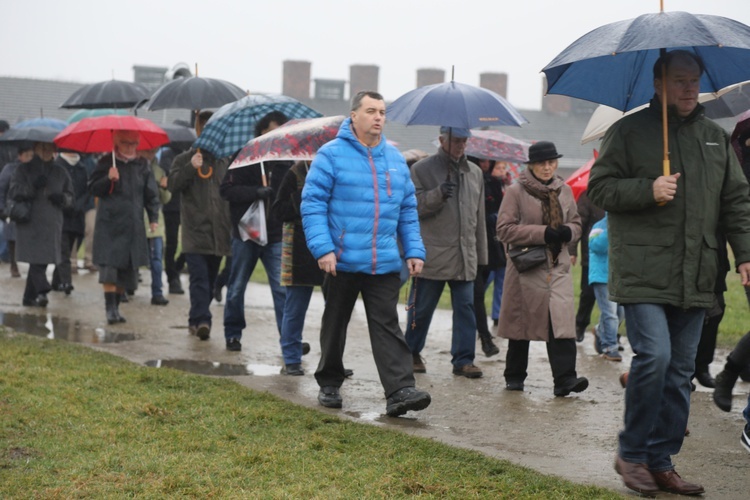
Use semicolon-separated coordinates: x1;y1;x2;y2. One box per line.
315;272;415;397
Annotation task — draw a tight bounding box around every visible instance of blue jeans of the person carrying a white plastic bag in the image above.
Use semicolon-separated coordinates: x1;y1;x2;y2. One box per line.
224;238;286;340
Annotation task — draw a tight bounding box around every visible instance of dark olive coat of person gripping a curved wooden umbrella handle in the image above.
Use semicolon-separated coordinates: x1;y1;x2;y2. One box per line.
167;149;232;255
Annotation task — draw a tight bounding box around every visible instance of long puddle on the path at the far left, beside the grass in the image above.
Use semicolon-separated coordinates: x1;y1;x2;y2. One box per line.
0;312;137;344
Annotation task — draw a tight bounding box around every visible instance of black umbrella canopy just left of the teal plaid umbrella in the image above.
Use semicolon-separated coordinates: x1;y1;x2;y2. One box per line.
146;76;247;111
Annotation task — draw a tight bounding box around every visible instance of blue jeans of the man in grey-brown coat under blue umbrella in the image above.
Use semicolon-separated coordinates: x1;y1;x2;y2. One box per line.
406;278;477;368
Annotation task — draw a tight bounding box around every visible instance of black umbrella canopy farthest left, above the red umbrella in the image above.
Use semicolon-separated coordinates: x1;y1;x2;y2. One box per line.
60;80;149;109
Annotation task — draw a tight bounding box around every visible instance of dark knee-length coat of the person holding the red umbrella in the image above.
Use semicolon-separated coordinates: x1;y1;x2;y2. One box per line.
89;155;159;269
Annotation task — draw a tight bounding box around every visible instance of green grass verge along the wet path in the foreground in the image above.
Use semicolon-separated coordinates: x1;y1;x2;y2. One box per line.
0;329;620;499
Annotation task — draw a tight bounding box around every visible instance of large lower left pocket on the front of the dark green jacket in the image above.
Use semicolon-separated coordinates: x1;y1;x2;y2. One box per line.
619;231;674;290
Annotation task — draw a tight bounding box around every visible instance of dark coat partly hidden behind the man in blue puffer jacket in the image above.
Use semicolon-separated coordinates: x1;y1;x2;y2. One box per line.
271;162;323;286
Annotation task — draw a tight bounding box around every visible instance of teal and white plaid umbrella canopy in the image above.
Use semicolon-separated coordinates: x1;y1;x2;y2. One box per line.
194;94;323;158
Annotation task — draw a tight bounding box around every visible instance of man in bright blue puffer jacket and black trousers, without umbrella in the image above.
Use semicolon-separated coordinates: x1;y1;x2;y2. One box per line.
301;91;430;416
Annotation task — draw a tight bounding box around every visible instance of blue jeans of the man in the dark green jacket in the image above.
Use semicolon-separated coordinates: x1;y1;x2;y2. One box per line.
619;304;705;472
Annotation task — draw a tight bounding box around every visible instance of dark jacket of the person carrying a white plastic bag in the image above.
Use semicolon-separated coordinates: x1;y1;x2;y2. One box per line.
221;157;292;241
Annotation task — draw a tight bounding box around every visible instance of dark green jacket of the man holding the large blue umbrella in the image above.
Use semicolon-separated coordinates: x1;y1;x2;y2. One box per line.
588;98;750;309
